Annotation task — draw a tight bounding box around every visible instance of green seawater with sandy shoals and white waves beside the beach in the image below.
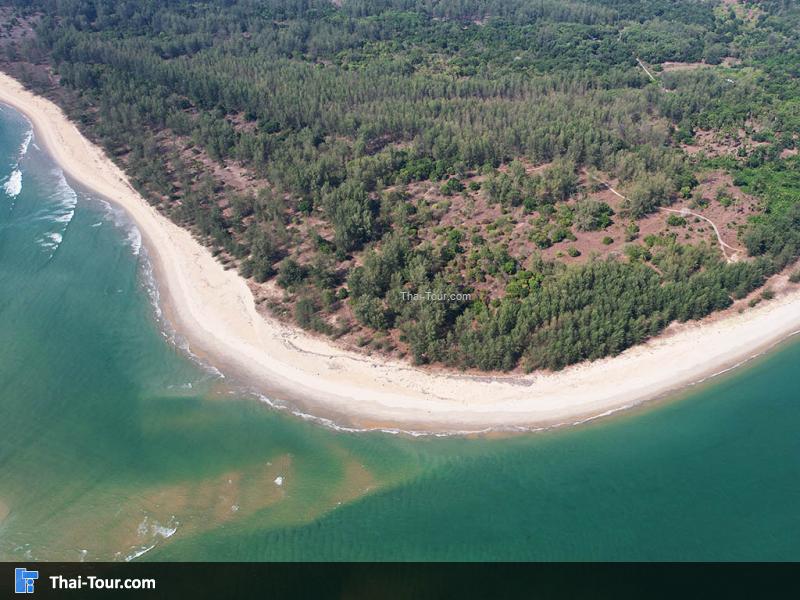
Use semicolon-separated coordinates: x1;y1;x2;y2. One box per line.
0;107;800;560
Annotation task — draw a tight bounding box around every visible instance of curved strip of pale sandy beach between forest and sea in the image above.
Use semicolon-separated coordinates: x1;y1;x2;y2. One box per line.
0;73;800;432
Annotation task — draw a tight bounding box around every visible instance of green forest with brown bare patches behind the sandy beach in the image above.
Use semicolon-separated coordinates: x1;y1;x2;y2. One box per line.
0;0;800;370
